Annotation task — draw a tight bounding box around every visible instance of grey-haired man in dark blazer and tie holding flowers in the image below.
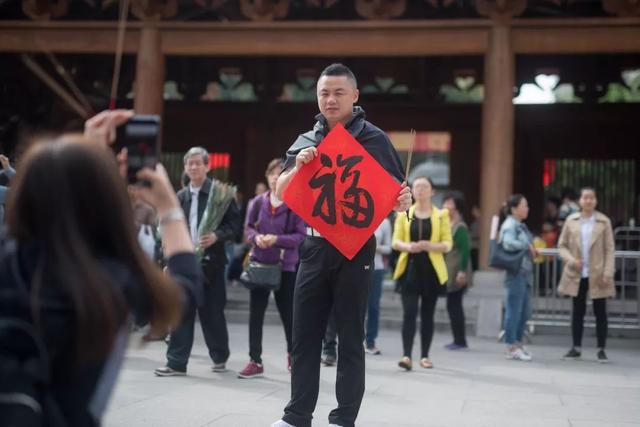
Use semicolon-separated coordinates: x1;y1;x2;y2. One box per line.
155;147;241;377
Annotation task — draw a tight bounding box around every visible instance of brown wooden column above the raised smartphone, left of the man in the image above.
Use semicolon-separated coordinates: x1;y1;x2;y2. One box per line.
134;22;164;116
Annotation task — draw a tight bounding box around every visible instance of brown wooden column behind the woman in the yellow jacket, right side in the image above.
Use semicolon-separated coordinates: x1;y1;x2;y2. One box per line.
479;21;515;268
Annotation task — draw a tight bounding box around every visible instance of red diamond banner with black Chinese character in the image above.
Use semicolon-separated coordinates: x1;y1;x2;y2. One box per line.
284;124;400;260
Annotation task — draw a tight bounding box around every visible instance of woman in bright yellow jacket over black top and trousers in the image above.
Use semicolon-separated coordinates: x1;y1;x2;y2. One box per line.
392;177;453;371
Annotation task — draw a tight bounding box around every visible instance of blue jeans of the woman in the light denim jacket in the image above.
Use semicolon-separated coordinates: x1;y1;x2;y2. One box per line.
504;272;531;345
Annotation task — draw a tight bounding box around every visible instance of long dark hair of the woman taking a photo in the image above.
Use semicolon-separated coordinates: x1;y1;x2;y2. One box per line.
7;137;181;362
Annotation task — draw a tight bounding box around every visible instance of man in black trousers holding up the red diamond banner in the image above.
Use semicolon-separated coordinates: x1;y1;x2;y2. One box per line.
272;64;411;427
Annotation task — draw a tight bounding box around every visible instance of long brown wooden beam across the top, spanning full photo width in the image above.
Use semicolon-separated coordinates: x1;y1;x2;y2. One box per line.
0;18;640;56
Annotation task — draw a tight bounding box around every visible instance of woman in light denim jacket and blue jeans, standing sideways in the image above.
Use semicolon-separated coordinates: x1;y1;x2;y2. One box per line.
499;194;536;361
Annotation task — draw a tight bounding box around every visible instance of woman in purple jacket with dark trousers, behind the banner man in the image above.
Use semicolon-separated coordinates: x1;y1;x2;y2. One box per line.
238;159;306;378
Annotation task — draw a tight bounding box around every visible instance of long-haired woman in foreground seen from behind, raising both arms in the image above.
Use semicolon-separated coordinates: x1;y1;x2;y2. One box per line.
0;110;202;427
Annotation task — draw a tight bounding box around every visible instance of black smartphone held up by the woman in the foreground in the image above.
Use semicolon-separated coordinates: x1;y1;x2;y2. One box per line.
122;115;161;184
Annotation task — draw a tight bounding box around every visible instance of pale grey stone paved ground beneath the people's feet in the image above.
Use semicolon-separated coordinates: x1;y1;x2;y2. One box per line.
104;324;640;427
